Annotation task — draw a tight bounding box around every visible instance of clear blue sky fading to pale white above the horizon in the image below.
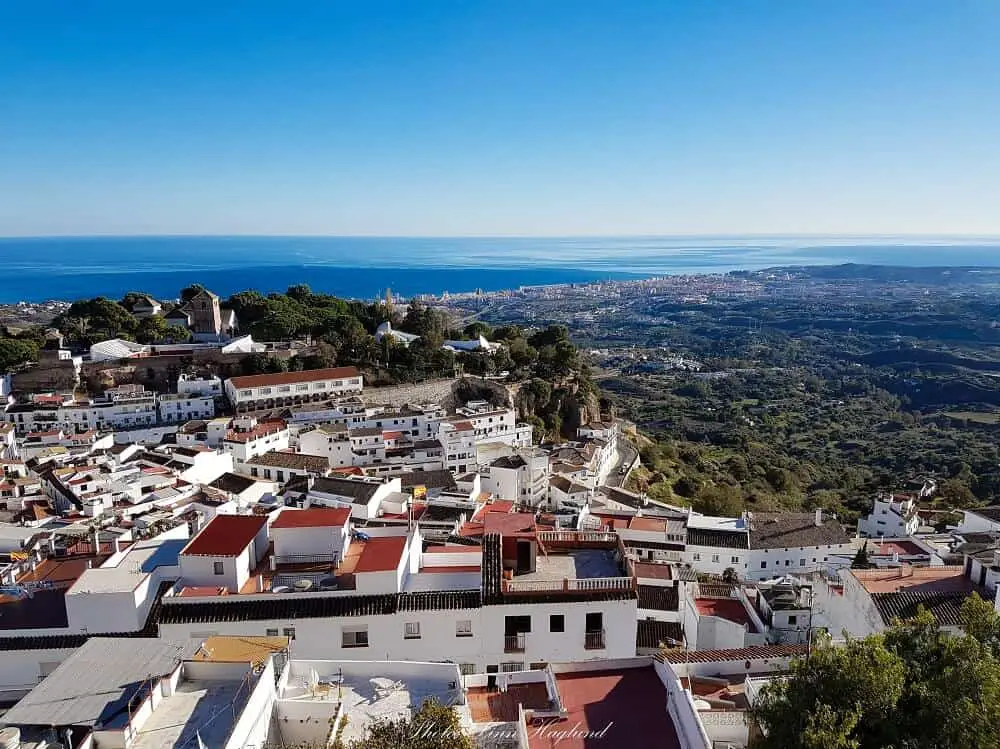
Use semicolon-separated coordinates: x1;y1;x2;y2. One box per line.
0;0;1000;235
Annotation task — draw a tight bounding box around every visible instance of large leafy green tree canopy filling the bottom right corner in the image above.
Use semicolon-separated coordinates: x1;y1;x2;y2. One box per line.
753;594;1000;749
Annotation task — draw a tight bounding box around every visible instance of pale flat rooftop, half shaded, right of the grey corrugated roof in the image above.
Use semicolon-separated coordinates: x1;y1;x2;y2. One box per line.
131;681;249;749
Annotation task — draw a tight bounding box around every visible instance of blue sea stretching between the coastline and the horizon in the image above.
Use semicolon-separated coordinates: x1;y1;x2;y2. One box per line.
0;236;1000;303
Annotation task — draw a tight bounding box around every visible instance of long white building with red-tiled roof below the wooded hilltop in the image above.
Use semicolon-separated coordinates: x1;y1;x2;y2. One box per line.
225;367;363;411
